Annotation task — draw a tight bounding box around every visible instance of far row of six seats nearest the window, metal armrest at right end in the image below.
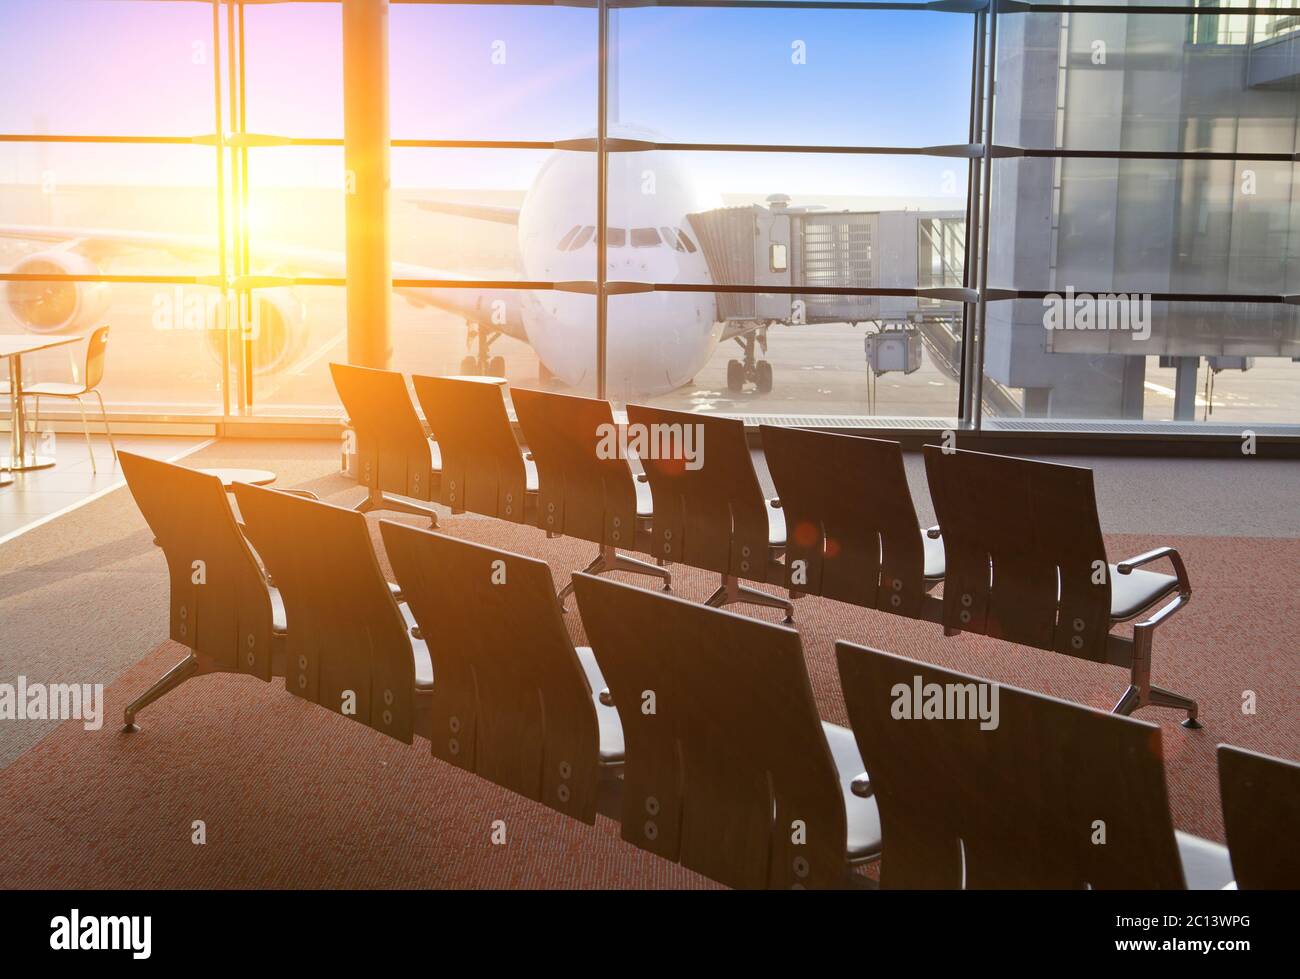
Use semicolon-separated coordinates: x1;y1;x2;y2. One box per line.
330;364;1199;728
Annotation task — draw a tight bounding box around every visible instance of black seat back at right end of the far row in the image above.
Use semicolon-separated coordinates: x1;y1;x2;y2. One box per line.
924;446;1110;663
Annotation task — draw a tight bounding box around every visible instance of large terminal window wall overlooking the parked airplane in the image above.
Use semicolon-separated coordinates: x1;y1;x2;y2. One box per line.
0;0;1300;426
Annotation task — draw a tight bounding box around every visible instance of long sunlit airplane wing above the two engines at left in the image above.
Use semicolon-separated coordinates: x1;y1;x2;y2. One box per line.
0;225;528;342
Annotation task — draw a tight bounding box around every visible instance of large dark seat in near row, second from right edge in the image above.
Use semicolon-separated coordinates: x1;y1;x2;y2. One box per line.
836;642;1232;889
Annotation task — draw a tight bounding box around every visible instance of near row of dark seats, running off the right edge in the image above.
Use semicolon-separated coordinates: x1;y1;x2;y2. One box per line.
122;452;1300;888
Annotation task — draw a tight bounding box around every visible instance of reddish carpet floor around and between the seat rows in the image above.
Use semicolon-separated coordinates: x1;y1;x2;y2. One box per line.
0;517;1300;888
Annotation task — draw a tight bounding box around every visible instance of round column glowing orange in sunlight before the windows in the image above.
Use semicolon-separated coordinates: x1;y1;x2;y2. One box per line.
343;0;393;368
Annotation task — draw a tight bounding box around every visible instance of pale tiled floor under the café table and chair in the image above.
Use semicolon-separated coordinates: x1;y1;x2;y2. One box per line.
0;433;211;543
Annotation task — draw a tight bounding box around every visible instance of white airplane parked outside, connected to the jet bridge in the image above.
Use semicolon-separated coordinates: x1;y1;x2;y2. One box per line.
0;125;771;400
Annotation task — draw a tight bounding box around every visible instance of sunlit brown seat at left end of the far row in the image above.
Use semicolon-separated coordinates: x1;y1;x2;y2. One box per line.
329;363;442;527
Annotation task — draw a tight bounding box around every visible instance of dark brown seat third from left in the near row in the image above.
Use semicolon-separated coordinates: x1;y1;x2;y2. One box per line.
380;520;624;823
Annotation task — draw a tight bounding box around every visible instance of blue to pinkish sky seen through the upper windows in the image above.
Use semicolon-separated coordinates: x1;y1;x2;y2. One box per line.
0;0;972;196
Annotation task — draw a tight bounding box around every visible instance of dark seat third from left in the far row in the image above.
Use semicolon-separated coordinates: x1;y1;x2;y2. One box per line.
512;389;672;607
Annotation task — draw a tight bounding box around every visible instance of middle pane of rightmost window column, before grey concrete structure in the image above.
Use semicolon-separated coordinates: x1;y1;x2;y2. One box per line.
989;159;1300;295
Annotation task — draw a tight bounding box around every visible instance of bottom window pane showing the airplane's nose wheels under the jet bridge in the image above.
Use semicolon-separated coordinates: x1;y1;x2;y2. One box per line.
608;286;962;416
